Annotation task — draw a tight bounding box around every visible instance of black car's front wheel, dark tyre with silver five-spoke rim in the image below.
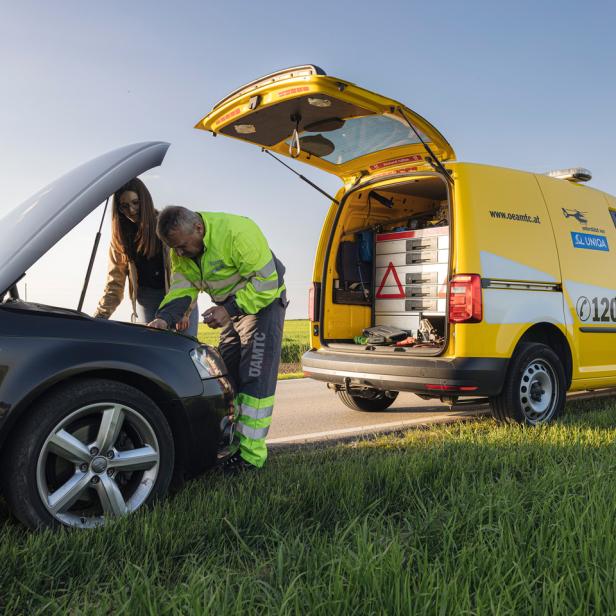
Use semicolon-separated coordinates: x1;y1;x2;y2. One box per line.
3;379;175;529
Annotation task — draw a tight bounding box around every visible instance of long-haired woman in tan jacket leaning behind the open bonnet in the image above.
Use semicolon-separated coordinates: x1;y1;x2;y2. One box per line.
94;178;199;337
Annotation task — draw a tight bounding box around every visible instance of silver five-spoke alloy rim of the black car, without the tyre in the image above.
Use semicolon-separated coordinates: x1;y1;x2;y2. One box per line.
37;402;160;528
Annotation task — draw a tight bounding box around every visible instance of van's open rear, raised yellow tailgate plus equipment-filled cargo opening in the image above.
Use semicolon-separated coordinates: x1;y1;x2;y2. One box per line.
196;65;455;354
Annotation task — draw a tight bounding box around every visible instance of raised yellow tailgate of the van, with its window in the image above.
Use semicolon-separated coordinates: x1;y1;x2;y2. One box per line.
195;65;455;182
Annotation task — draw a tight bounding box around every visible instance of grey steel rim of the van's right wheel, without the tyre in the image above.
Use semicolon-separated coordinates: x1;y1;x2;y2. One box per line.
520;359;558;424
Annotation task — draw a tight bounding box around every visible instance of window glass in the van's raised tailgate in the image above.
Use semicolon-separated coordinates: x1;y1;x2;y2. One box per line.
286;115;430;165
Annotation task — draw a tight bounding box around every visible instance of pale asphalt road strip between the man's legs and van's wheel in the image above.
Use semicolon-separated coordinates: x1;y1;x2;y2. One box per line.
267;379;487;445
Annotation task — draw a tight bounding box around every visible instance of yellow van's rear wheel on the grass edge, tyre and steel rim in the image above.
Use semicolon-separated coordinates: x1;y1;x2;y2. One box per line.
490;342;566;426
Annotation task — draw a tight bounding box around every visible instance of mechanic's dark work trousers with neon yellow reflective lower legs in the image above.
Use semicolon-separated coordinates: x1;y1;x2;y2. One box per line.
219;293;287;467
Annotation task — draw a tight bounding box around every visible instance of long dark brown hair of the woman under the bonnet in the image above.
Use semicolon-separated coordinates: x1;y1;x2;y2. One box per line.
111;178;161;260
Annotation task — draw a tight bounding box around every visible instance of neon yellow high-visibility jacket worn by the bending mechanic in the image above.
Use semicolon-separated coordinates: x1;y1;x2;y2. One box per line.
157;212;285;325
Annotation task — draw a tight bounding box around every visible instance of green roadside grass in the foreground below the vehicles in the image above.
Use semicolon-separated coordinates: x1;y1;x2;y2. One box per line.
0;401;616;616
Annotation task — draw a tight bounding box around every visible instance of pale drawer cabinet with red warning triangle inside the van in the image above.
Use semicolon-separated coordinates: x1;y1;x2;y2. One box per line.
372;226;449;334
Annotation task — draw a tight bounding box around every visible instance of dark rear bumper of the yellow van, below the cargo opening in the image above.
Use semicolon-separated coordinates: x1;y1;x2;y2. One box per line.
302;349;508;398
